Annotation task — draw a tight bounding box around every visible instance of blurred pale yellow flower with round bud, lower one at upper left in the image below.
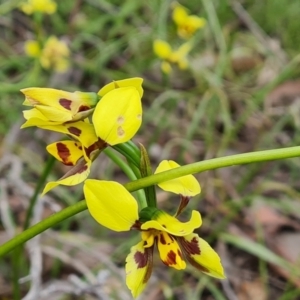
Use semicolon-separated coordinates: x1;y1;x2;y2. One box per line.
24;36;70;72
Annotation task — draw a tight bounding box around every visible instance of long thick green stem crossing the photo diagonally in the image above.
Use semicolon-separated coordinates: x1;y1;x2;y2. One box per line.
0;147;300;257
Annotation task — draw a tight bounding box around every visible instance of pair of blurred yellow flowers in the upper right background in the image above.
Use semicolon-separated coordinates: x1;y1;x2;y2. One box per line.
153;4;206;74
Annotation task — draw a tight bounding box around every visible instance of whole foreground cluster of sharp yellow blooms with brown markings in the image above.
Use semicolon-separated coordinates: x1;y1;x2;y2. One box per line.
22;78;225;297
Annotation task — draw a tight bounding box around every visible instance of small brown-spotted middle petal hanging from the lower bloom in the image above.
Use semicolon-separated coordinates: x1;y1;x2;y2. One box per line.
157;232;186;270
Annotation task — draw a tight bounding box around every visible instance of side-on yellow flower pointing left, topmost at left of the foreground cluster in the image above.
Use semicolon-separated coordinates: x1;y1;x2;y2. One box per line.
21;87;99;128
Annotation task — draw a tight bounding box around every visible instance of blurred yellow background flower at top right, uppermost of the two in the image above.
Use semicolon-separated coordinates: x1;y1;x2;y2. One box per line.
172;4;206;39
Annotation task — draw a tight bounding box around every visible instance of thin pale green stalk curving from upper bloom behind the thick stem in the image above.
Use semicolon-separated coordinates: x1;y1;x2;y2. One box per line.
103;148;147;208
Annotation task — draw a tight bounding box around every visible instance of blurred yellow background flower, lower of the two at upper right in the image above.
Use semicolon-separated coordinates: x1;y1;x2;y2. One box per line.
153;40;192;74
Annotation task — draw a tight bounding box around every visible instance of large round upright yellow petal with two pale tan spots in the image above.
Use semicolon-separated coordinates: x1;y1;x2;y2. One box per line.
93;87;142;146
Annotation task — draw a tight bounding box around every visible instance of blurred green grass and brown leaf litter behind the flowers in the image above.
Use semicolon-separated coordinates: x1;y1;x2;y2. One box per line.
0;0;300;300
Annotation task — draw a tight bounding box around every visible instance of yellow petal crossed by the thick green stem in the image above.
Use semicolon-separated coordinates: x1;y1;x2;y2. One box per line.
155;160;201;197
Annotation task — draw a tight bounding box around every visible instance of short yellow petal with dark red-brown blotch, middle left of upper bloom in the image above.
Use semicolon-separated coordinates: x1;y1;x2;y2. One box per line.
46;141;83;166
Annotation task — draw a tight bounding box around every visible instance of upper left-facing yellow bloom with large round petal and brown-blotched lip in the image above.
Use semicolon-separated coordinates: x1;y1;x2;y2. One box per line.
37;81;142;194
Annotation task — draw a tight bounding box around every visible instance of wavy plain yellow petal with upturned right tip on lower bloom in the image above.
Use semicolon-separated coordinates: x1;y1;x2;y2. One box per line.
141;210;202;236
